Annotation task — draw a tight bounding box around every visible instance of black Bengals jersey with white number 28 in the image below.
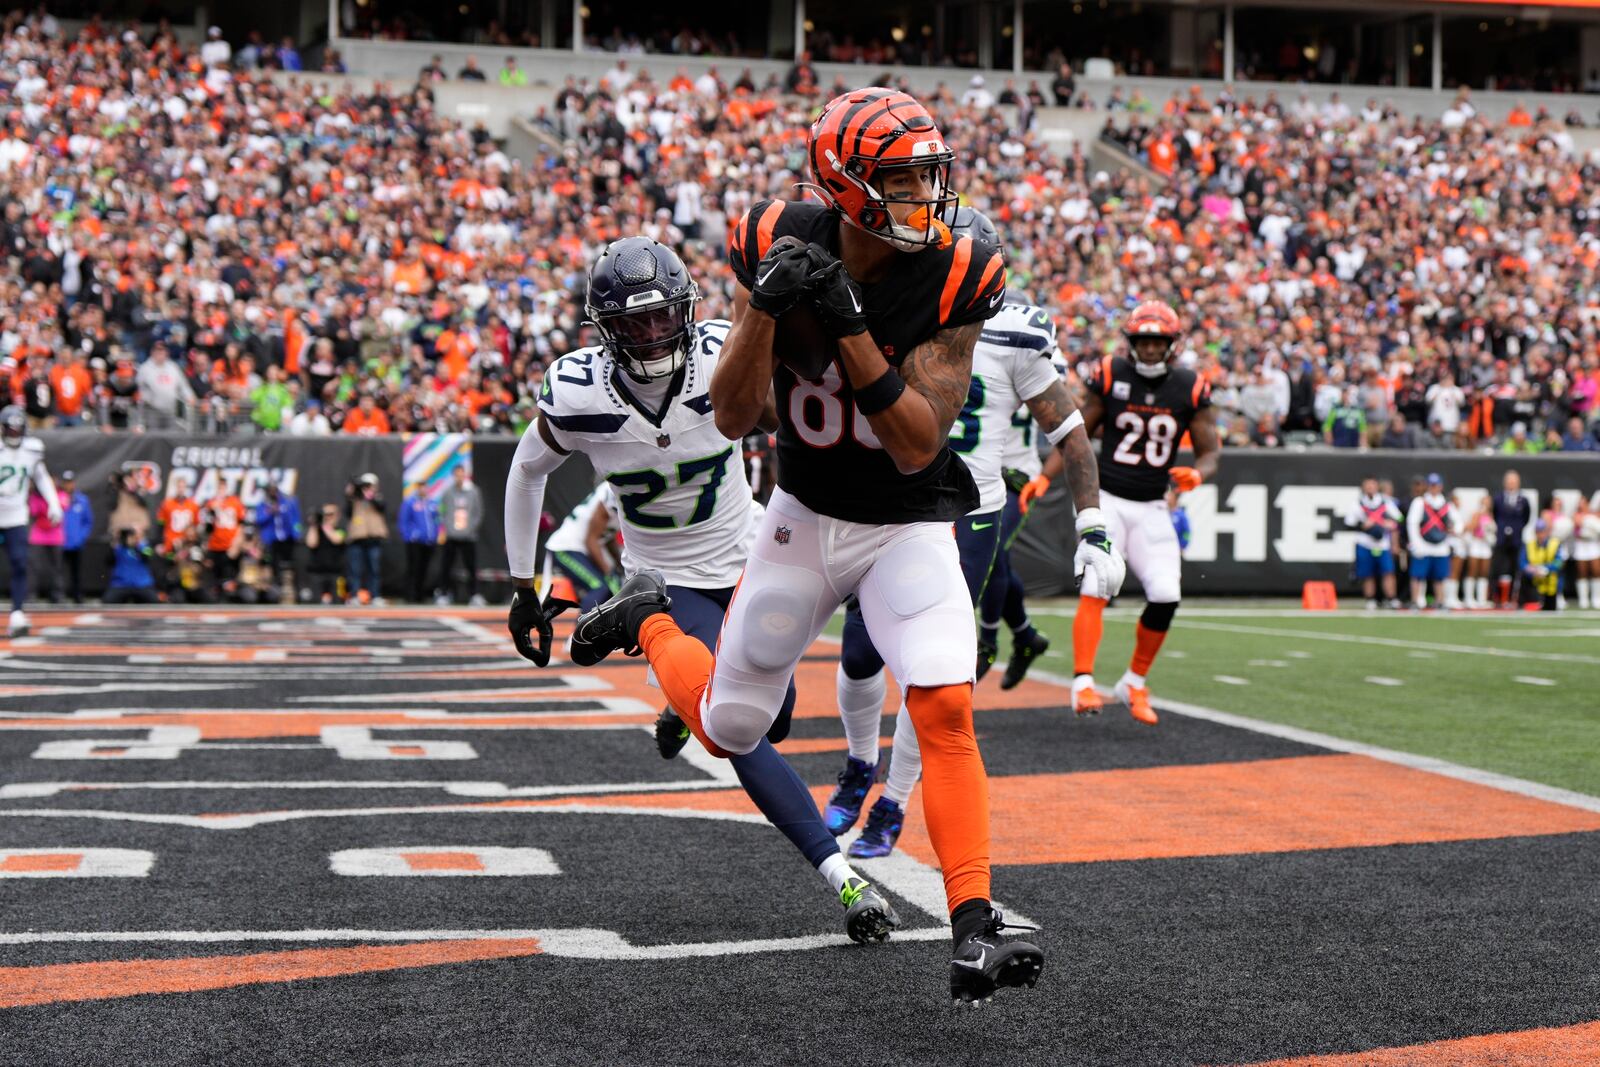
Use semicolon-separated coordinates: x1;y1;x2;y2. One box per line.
1083;355;1211;501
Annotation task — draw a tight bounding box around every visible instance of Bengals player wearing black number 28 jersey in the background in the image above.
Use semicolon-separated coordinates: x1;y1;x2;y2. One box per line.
1072;301;1222;726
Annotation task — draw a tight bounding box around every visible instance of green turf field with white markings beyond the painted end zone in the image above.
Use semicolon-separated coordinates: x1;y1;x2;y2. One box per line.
1011;600;1600;795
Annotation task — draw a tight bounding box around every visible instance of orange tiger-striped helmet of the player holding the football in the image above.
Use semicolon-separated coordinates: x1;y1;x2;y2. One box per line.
806;86;955;251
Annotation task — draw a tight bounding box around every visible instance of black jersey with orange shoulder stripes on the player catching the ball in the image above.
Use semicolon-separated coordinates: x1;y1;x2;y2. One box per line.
728;200;1005;525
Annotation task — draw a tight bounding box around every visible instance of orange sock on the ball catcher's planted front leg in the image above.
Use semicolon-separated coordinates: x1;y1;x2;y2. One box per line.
906;685;989;912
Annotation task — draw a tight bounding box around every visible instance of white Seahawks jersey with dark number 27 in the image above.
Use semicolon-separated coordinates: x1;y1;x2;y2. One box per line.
539;318;752;589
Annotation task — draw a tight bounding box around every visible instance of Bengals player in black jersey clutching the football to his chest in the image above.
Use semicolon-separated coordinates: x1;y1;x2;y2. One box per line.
571;88;1120;1003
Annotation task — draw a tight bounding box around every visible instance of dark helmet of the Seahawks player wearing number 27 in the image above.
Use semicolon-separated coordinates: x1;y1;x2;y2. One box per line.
584;237;699;381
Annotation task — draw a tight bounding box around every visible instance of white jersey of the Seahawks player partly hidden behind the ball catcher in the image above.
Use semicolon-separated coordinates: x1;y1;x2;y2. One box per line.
950;304;1056;514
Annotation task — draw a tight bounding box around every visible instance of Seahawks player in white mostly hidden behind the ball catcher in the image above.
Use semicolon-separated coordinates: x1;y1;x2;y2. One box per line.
822;262;1122;857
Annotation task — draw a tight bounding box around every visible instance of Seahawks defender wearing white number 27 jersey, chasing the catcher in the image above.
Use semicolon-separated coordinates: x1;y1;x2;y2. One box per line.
506;237;899;942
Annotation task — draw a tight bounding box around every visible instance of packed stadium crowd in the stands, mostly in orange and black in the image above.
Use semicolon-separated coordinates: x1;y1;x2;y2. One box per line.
0;16;1600;453
